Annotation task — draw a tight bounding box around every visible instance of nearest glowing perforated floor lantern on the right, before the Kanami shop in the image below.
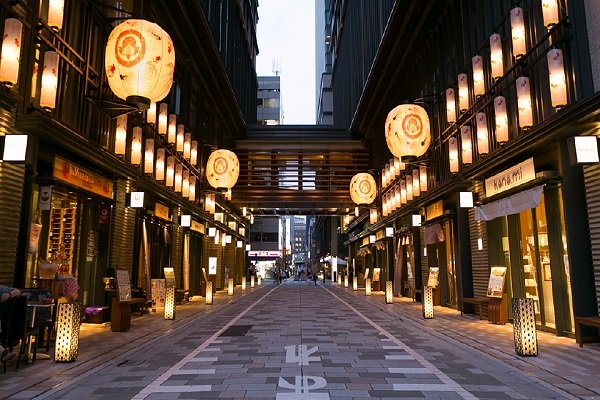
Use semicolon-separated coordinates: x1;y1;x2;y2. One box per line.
512;298;538;356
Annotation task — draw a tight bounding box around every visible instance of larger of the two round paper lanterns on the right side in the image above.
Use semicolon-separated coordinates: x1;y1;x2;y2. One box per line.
385;104;431;160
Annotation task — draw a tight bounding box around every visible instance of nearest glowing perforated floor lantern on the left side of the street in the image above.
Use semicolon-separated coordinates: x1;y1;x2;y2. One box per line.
54;302;81;362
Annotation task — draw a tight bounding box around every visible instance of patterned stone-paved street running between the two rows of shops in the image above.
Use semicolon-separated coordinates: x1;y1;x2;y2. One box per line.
0;281;600;400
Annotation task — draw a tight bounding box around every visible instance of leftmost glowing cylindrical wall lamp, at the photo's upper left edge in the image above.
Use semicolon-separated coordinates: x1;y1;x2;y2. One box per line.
0;18;23;86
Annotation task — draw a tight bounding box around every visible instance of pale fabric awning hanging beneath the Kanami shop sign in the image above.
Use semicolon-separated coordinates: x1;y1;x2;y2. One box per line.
475;185;544;221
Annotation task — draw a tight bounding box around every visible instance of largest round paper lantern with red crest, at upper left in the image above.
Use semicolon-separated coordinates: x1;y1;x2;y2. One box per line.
104;19;175;109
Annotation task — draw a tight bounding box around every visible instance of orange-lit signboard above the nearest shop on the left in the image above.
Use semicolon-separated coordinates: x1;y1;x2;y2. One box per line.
53;156;113;199
